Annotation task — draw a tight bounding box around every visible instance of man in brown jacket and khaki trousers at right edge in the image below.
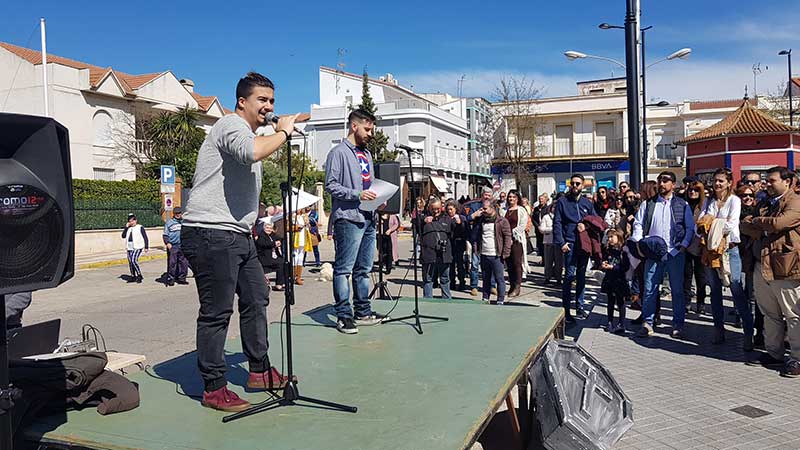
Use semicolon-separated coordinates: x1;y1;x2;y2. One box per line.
742;167;800;377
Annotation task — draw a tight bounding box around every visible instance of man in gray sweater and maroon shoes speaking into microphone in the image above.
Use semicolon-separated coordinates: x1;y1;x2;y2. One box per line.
181;72;297;411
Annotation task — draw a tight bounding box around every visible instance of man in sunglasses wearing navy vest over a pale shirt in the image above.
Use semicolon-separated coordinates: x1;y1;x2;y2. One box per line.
631;171;695;338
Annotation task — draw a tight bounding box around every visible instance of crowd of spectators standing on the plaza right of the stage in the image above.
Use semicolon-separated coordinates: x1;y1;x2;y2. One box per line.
396;167;800;377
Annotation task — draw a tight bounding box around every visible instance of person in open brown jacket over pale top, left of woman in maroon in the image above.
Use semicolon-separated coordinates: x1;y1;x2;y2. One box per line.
471;200;512;305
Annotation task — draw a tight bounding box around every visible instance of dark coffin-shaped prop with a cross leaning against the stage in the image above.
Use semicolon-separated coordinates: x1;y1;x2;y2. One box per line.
528;340;633;450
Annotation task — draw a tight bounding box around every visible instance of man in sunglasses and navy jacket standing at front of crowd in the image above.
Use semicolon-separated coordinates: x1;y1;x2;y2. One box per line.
553;173;596;323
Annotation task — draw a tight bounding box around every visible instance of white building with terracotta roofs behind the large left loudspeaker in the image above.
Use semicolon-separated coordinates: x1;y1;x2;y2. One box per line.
0;42;226;180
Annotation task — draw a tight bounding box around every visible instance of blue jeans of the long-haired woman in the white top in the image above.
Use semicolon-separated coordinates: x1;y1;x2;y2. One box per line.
706;247;753;336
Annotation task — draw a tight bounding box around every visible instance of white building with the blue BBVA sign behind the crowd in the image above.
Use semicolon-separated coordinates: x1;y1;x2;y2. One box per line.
492;78;741;198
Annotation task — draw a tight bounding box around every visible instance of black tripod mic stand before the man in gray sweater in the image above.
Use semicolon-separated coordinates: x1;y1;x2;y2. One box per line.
222;137;358;423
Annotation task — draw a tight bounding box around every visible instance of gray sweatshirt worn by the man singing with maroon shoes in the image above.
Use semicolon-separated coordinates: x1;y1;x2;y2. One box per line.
183;114;261;233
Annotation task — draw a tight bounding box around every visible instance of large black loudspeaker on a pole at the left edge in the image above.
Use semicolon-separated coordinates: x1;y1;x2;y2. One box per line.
0;113;75;295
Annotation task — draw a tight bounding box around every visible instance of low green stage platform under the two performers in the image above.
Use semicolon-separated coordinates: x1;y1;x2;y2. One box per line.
25;299;562;450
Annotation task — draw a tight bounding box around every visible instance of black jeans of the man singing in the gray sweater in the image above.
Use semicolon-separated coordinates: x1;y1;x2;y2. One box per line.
181;226;270;392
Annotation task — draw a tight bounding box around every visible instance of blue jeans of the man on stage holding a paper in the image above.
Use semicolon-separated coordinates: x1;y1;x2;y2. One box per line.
333;219;375;319
